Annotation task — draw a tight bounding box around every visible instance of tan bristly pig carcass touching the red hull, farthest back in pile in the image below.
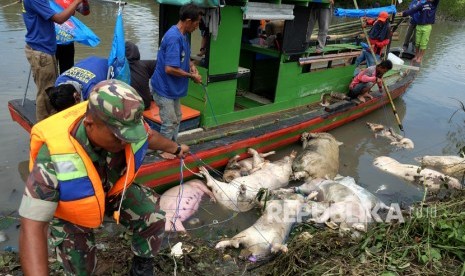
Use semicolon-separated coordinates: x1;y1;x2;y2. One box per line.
292;132;342;180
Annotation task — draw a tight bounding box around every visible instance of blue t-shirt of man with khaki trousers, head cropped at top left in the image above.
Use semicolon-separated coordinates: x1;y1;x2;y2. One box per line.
22;0;57;55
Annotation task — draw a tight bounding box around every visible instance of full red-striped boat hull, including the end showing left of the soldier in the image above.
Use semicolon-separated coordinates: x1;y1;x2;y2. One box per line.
8;71;416;191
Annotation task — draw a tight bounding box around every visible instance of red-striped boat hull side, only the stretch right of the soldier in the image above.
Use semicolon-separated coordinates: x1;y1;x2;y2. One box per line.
137;73;414;190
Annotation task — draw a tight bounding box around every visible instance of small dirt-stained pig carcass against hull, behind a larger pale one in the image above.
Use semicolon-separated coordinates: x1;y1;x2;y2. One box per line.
223;148;275;183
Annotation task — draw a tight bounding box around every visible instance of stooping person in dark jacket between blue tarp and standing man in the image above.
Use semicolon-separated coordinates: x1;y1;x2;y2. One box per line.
125;41;157;110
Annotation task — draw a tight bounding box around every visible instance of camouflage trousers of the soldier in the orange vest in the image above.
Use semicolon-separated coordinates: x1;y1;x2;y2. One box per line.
49;184;165;275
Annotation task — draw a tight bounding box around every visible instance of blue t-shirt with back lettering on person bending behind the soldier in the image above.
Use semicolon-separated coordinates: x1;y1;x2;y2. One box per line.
55;56;108;100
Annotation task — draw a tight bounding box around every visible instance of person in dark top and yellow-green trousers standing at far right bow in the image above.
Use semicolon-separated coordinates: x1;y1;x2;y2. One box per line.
400;0;439;63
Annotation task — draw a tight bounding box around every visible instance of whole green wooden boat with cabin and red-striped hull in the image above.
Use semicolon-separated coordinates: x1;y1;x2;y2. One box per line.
9;0;417;190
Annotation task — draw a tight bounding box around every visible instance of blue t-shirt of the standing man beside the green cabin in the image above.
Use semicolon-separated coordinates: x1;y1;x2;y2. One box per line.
150;25;191;99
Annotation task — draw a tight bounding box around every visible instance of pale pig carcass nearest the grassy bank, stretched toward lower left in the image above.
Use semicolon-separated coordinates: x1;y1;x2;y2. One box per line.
215;196;304;261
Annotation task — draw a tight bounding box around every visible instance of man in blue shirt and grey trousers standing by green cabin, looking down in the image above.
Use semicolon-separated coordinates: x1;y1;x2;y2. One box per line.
150;4;202;159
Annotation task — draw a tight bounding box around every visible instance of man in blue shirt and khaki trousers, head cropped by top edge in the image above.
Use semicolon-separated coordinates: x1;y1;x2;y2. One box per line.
22;0;82;122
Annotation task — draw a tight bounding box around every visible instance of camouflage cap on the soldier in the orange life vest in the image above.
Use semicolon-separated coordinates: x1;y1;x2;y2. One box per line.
88;79;147;143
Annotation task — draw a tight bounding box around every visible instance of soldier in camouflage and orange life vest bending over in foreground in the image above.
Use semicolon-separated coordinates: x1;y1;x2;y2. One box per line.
19;80;189;275
